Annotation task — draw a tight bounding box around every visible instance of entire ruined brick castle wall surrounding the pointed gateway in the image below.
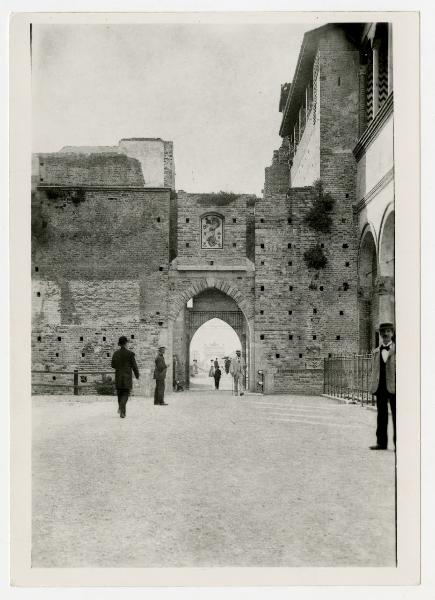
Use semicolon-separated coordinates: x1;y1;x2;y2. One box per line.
32;28;363;393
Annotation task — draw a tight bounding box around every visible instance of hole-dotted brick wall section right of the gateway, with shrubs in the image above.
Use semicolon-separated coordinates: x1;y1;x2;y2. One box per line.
255;187;358;393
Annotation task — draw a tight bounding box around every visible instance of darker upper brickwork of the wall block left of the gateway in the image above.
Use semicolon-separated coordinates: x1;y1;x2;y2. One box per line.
32;188;169;281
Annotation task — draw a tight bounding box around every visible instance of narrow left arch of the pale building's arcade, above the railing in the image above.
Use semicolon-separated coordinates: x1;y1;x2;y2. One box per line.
358;231;378;353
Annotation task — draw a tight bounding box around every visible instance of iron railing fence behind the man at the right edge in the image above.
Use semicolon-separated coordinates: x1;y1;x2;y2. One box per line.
323;354;375;405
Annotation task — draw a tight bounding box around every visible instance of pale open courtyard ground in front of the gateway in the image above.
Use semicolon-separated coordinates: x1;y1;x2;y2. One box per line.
32;390;395;567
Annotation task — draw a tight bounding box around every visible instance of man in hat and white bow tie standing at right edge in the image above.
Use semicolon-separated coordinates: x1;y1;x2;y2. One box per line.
370;323;396;450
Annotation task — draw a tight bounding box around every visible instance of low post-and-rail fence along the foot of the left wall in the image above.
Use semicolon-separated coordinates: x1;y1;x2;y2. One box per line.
32;369;115;396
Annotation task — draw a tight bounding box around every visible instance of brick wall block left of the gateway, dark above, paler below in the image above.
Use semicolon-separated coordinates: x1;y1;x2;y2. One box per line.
32;189;169;395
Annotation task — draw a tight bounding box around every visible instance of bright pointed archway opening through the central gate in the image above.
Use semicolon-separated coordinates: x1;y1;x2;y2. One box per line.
189;318;242;391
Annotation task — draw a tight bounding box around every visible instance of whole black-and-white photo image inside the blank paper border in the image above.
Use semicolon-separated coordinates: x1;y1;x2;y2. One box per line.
7;13;419;588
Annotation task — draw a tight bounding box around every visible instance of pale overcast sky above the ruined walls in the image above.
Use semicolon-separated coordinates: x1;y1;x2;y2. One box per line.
32;24;314;195
